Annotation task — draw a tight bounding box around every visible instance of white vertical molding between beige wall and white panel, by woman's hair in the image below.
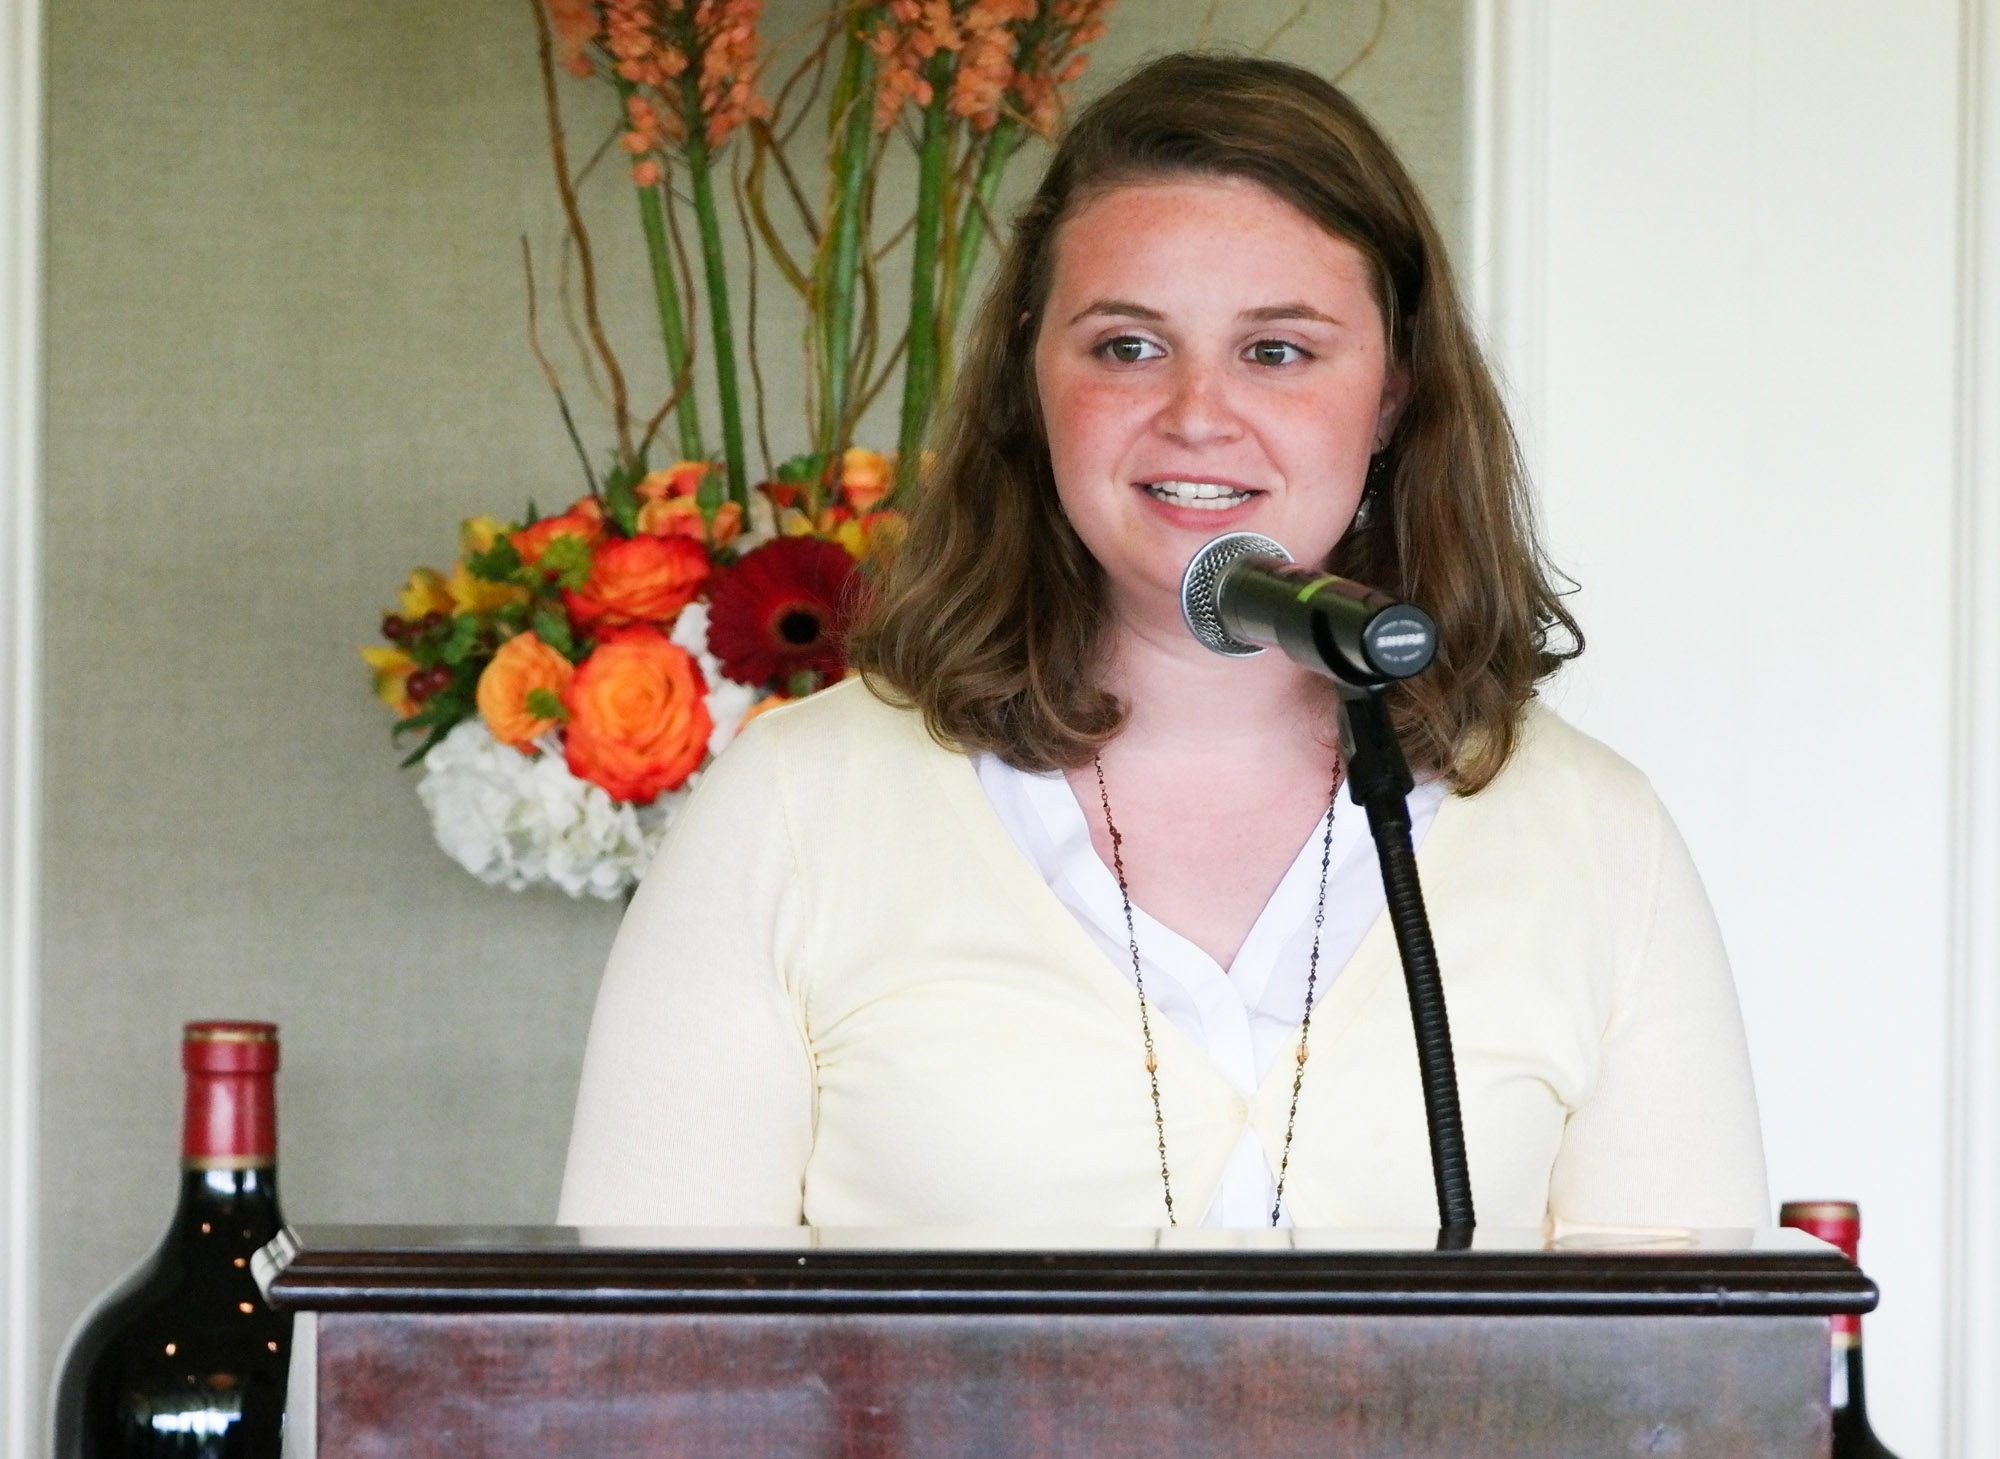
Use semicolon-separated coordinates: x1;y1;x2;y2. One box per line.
1464;0;1550;480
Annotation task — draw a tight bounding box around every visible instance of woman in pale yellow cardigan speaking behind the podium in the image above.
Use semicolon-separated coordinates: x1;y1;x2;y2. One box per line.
560;54;1768;1227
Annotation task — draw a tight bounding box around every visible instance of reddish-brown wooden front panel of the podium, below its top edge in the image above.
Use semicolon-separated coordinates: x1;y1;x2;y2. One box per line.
316;1311;1828;1459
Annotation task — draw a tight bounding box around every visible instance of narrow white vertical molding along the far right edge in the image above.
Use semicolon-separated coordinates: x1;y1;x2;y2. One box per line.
1944;0;2000;1459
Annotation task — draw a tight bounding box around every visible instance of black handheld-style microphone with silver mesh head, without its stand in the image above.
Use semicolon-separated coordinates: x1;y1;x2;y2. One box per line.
1180;532;1438;694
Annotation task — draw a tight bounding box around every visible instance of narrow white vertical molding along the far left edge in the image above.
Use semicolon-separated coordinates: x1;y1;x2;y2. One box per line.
0;0;44;1459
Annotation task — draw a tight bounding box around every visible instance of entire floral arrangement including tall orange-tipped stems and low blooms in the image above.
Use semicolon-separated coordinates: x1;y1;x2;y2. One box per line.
362;0;1112;897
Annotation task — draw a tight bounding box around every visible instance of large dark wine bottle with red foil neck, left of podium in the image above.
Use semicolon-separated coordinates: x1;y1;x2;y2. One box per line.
56;1023;292;1459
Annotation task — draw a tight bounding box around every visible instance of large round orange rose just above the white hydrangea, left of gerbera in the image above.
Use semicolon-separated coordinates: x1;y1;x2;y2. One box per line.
562;626;714;805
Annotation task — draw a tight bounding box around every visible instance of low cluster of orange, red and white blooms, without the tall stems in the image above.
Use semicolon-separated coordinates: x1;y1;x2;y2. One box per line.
362;450;900;897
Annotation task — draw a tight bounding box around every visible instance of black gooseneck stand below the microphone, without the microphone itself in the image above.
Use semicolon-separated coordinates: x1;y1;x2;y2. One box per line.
1340;684;1472;1251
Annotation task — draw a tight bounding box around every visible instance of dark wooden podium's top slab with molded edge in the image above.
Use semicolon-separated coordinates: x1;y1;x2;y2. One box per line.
254;1225;1876;1315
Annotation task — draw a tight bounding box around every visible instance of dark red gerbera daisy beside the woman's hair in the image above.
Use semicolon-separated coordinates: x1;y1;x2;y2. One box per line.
708;538;858;692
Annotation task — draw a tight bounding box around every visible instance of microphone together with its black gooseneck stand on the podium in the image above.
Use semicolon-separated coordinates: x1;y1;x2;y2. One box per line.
1180;532;1472;1251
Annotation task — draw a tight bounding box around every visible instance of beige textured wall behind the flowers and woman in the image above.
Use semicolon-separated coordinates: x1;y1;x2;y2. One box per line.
42;0;1460;1383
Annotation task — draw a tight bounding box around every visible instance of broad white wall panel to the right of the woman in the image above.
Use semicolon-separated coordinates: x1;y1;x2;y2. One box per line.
1472;0;1960;1455
